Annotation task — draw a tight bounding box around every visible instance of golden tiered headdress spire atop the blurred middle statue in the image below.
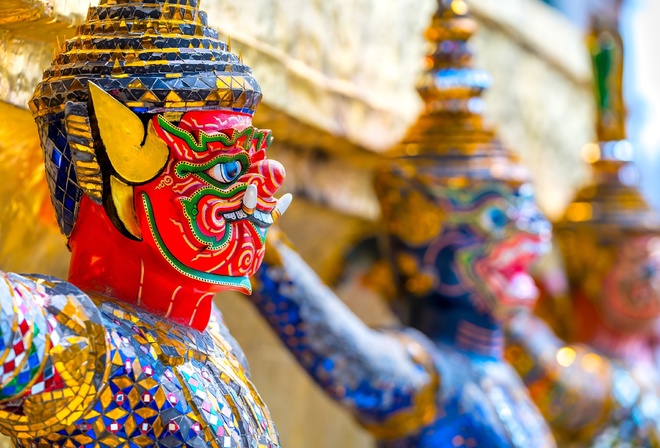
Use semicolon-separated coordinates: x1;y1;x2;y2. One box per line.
392;0;528;182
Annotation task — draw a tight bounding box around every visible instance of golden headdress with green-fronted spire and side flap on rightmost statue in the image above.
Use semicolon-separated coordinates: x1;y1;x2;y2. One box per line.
554;19;660;302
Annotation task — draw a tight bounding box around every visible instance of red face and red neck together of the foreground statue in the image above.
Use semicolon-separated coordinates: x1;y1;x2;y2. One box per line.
69;110;290;330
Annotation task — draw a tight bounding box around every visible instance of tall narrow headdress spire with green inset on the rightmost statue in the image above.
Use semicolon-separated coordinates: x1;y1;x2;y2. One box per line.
557;5;660;231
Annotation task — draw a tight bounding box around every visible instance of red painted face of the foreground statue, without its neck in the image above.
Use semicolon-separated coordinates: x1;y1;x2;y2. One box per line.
135;111;285;292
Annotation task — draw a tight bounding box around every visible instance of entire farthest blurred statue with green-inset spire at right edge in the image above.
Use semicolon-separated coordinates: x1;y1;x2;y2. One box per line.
507;6;660;447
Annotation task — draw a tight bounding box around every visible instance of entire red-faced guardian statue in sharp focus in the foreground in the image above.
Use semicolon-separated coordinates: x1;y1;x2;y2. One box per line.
0;0;290;447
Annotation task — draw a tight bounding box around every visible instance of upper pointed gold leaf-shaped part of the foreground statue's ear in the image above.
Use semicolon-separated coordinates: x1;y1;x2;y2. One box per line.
89;82;169;185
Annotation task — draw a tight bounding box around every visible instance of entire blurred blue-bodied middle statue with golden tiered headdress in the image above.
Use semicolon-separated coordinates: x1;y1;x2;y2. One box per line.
253;0;555;448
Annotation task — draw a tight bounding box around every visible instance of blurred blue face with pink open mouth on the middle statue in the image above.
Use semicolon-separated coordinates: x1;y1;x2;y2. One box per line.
381;172;550;318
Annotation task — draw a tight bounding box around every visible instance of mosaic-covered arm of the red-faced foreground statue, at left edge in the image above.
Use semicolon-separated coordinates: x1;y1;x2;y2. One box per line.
0;272;107;438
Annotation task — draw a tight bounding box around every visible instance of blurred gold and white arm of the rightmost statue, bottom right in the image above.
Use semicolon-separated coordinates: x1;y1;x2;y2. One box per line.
506;312;616;440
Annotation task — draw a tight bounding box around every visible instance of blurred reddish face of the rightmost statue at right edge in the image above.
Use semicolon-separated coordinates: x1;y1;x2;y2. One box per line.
600;236;660;331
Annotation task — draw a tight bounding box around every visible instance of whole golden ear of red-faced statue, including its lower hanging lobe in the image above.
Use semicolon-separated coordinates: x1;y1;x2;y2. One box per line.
83;82;169;240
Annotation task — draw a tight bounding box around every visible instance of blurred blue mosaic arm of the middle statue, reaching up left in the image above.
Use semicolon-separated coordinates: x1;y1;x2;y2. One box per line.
252;235;438;437
